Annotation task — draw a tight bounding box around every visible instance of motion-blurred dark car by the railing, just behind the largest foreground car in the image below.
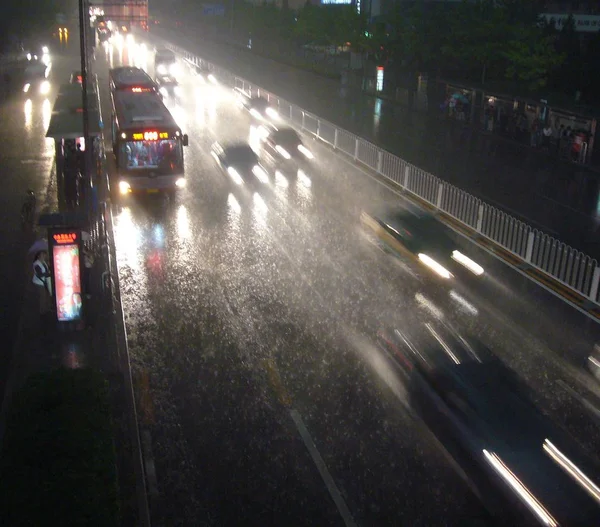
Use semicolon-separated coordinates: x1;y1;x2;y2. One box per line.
361;208;484;283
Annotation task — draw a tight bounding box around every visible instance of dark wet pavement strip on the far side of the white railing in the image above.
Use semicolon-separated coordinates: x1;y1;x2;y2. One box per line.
151;26;600;258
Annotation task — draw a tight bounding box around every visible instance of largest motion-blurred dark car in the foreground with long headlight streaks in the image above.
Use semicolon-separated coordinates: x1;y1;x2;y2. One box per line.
379;323;600;526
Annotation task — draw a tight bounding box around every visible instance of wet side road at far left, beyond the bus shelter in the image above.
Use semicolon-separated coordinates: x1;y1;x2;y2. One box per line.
0;41;77;404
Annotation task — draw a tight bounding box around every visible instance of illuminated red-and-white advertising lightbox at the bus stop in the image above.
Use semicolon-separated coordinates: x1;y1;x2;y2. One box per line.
49;231;83;322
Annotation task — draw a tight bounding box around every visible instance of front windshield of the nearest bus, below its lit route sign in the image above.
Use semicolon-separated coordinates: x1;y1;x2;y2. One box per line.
120;139;183;173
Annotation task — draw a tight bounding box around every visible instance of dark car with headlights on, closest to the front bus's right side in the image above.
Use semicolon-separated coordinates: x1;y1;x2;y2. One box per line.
211;143;269;185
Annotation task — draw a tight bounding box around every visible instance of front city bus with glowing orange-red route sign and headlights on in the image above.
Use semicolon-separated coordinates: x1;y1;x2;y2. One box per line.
111;86;188;196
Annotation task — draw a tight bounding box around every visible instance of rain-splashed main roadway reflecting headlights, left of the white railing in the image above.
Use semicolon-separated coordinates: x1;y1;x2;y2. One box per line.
98;35;598;526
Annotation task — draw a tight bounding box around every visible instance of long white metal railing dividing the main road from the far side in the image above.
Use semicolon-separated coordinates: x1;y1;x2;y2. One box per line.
146;32;600;303
